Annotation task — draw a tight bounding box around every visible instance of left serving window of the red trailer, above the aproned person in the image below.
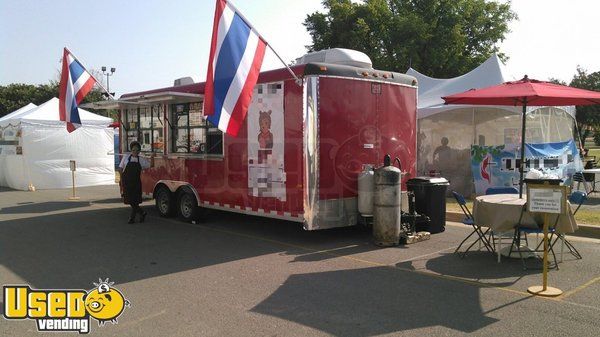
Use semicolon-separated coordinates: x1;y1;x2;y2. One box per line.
123;104;164;152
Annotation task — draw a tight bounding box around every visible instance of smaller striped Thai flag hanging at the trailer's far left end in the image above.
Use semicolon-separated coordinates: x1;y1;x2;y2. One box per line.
58;48;96;133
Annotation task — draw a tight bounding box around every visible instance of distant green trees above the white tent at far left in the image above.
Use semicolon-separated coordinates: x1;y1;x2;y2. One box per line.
0;81;106;117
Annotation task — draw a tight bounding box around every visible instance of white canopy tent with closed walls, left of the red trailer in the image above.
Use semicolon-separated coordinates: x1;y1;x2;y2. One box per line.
0;98;115;190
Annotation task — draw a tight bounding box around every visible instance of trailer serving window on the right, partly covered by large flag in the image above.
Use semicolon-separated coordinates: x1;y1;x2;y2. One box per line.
171;102;223;155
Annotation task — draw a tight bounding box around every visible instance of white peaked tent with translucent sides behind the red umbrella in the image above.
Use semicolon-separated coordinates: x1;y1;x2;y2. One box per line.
407;54;575;195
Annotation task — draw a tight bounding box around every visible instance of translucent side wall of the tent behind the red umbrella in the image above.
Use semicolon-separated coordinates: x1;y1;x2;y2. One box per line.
417;106;574;195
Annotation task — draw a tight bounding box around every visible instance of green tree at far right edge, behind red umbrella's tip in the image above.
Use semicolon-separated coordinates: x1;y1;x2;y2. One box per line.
570;67;600;145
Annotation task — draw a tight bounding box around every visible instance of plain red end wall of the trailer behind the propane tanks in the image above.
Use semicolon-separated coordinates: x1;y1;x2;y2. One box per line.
319;78;417;200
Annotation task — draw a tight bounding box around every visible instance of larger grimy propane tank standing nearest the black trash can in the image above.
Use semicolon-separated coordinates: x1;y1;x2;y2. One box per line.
373;155;402;246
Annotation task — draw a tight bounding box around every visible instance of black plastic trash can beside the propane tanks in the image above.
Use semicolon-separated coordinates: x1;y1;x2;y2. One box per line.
406;177;450;234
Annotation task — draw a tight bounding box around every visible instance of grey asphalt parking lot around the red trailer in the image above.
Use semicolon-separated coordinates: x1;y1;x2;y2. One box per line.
0;185;600;337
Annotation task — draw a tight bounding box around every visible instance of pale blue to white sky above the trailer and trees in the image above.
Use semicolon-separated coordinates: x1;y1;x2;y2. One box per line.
0;0;600;96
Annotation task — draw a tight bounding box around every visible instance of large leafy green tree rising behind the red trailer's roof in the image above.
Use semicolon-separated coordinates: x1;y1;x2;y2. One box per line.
304;0;517;77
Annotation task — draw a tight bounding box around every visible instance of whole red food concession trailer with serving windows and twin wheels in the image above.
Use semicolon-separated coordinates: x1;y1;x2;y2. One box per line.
106;55;417;230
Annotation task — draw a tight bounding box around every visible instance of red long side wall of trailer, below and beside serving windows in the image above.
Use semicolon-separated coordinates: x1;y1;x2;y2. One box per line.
142;80;303;217
